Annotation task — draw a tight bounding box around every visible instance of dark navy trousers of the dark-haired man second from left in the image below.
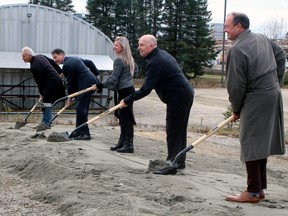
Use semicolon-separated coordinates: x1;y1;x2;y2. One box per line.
75;92;92;136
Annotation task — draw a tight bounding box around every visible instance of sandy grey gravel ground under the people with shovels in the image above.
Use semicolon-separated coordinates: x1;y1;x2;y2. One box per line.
0;89;288;216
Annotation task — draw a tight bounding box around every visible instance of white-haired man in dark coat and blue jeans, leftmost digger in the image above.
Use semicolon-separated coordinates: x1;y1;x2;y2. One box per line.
22;47;65;131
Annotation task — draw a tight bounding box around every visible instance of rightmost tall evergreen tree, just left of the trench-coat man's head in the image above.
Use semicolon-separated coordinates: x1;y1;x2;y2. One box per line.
179;0;217;78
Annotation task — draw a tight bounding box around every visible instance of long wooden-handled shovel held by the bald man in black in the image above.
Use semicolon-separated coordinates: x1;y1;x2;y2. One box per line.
47;104;120;142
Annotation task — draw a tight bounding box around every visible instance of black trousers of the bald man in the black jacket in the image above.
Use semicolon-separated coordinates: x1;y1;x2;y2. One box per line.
166;97;193;163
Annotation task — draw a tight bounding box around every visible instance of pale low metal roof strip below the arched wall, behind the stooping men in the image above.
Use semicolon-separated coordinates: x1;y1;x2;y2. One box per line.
0;52;113;71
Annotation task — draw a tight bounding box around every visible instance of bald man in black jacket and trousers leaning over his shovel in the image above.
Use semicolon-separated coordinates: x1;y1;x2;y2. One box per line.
120;35;194;169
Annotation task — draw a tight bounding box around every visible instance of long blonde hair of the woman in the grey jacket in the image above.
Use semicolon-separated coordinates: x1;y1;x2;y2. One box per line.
115;36;135;75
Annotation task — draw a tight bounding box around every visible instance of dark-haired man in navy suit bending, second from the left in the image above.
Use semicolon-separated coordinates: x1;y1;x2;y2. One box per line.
52;49;98;140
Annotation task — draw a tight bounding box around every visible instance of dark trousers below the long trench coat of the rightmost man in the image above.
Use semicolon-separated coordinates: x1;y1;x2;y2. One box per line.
245;158;267;193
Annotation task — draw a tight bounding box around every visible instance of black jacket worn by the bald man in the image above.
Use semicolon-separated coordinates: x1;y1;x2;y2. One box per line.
124;47;194;104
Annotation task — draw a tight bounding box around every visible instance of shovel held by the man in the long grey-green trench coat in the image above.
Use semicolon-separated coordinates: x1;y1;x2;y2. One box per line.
153;116;233;175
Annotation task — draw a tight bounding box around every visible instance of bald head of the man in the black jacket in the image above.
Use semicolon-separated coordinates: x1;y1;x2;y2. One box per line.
138;34;157;57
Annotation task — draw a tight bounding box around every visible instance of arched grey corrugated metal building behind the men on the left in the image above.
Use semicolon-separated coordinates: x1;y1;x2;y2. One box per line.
0;4;114;111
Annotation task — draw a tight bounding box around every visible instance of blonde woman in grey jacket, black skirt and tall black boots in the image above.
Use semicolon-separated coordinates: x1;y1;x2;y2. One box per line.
97;36;136;153
